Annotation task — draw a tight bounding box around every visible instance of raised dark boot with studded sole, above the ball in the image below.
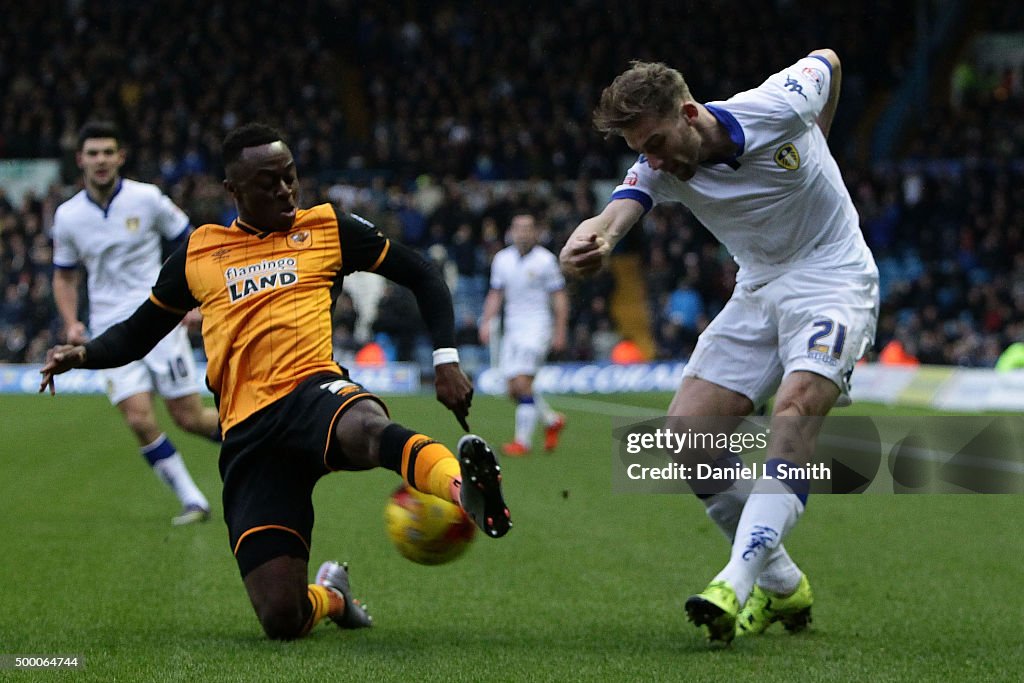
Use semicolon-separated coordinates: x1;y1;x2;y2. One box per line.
459;434;512;539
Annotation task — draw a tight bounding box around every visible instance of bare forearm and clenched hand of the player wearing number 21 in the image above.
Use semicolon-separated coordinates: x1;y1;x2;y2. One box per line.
558;199;644;278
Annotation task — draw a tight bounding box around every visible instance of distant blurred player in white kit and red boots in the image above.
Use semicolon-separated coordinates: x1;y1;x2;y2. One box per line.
480;213;568;456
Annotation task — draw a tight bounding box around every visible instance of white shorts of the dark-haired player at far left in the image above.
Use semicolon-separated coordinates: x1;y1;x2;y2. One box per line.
102;325;200;405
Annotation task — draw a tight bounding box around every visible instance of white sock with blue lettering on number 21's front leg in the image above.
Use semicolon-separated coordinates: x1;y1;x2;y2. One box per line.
715;478;804;604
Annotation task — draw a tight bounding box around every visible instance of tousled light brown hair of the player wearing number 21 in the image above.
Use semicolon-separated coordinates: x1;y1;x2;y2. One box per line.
594;60;690;135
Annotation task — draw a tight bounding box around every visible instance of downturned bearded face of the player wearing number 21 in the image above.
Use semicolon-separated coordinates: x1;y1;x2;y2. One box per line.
623;110;700;180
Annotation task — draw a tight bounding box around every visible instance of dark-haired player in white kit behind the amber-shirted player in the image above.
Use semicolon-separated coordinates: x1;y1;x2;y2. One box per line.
53;122;220;524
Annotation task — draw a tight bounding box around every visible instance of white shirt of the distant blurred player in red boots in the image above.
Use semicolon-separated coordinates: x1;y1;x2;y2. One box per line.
490;245;565;336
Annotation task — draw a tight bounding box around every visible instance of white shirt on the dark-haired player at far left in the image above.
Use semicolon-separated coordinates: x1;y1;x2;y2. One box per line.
53;178;189;337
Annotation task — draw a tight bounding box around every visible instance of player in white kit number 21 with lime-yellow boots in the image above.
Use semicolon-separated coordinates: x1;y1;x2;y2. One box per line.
560;49;879;642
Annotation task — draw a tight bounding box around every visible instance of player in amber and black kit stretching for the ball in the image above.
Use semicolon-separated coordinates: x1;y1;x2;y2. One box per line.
40;124;511;640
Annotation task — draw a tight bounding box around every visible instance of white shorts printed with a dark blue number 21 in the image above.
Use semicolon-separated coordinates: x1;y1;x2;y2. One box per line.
683;269;879;405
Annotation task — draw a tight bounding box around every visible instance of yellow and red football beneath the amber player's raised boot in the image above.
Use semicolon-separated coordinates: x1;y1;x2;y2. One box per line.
384;484;476;564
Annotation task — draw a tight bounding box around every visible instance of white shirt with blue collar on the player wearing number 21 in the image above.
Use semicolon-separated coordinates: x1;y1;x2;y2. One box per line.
611;56;877;285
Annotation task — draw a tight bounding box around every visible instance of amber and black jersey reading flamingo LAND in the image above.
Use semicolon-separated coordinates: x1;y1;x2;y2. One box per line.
151;204;391;431
